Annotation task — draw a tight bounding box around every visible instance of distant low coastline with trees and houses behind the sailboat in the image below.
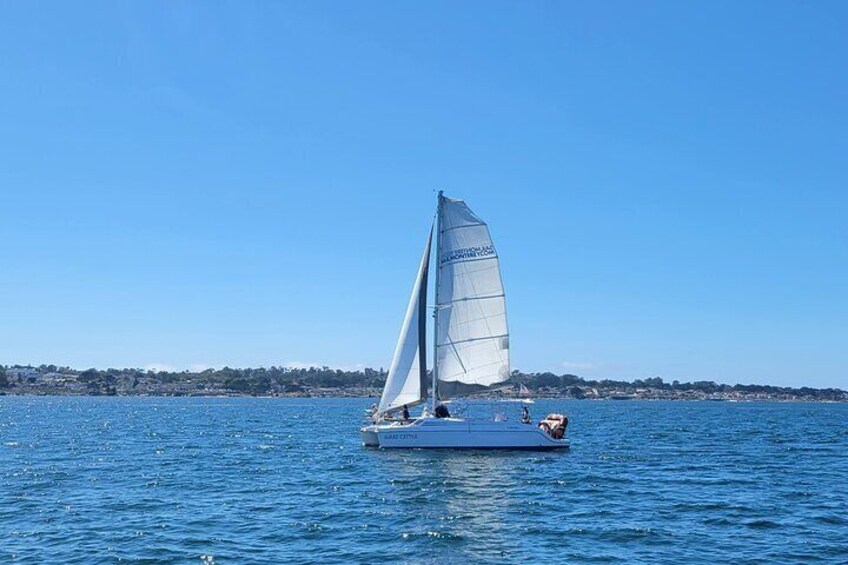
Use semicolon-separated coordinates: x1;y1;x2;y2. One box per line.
0;365;848;402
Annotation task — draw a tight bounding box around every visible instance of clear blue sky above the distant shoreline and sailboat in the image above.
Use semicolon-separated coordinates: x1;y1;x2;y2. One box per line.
0;1;848;387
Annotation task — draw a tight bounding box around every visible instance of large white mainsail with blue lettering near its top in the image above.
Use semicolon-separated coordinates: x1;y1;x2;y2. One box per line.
436;198;510;399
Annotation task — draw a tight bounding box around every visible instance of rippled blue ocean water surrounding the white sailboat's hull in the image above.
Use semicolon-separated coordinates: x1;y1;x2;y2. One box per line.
0;397;848;564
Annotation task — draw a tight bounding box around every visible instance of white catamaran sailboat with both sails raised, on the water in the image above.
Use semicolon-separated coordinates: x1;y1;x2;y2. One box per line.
360;192;569;449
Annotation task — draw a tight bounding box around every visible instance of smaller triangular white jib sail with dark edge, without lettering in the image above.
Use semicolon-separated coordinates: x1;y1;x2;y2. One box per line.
377;225;433;414
